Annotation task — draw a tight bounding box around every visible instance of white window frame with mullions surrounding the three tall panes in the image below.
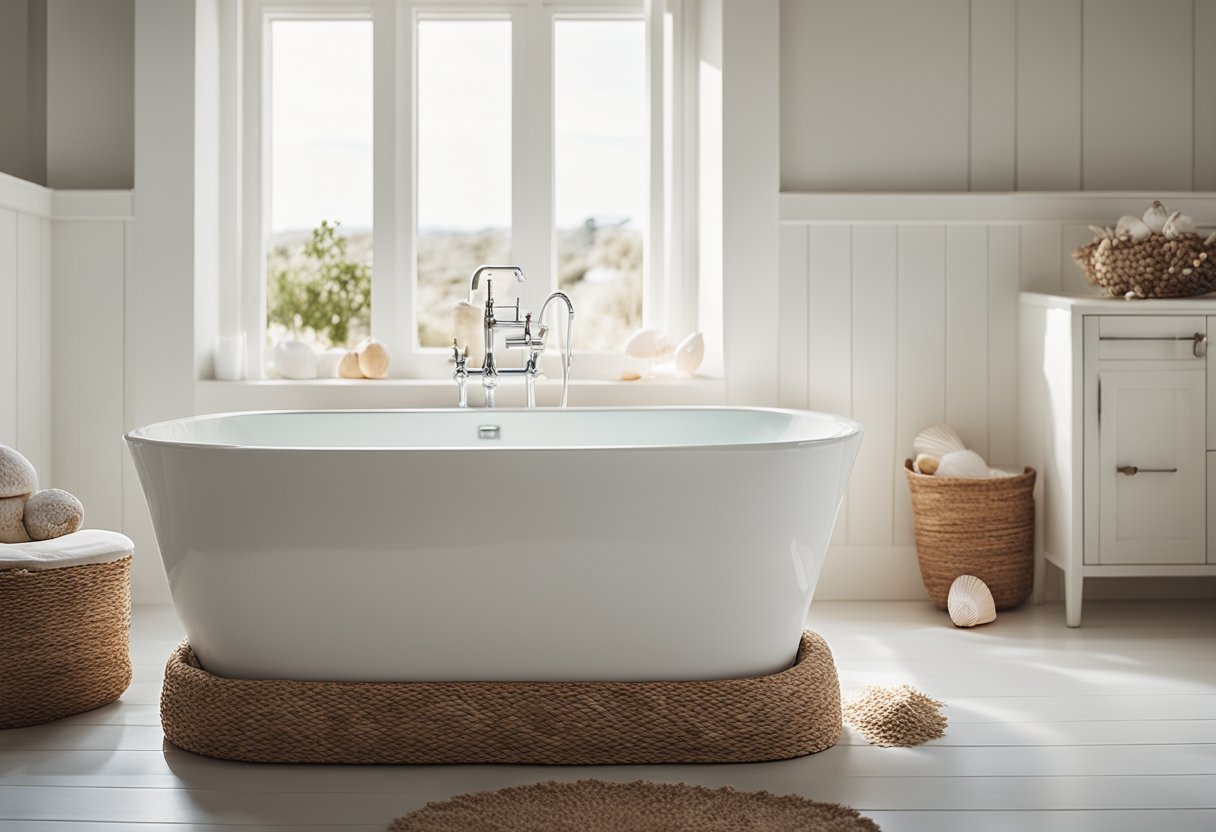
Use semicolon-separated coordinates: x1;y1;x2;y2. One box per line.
239;0;698;380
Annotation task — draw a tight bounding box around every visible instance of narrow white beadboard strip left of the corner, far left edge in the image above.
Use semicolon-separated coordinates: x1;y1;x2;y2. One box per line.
0;174;54;485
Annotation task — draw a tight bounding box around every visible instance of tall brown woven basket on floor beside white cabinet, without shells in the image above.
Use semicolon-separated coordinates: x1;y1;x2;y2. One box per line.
903;460;1035;609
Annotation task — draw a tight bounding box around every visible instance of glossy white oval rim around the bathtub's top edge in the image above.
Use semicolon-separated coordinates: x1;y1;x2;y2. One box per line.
123;405;865;454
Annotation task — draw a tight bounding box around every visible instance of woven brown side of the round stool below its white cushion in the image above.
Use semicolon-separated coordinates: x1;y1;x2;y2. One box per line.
0;556;131;729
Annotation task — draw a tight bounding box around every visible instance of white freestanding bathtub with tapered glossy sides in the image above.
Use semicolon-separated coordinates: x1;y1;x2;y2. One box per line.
126;407;861;681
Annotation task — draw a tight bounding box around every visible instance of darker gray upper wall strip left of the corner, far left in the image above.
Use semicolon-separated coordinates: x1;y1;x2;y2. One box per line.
0;0;46;185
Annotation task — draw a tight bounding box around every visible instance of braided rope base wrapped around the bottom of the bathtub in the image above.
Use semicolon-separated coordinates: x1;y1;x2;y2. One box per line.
161;633;840;765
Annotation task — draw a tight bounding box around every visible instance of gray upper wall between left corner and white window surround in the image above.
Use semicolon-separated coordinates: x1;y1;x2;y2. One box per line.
46;0;135;189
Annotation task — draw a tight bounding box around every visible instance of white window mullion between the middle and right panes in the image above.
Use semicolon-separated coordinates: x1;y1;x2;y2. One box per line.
511;0;557;321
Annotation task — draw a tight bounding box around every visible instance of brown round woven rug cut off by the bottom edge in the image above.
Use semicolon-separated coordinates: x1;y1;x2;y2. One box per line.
389;780;878;832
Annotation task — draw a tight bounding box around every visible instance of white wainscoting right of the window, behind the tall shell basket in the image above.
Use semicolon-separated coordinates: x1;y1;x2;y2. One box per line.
779;192;1216;600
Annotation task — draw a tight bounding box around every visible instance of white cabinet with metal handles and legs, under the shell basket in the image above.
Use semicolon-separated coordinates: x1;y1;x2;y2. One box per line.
1019;293;1216;626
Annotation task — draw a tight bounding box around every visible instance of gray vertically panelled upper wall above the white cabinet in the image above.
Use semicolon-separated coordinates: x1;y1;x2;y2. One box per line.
781;0;1216;192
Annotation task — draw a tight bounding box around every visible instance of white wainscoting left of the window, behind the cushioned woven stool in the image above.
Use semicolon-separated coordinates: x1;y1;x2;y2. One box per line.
0;174;133;557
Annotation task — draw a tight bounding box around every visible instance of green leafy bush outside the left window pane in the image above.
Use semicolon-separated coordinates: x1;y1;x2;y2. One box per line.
266;220;372;348
